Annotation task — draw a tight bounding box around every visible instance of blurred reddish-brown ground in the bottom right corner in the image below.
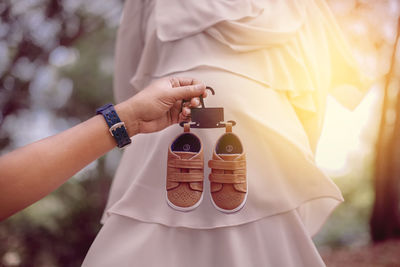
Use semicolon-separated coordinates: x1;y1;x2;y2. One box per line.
320;240;400;267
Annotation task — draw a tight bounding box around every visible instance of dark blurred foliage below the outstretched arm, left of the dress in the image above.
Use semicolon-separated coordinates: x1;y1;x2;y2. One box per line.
0;160;111;267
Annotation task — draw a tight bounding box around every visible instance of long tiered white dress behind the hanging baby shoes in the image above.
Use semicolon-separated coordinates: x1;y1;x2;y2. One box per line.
83;0;365;267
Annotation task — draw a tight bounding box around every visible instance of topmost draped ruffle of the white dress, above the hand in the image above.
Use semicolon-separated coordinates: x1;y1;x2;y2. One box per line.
131;0;365;116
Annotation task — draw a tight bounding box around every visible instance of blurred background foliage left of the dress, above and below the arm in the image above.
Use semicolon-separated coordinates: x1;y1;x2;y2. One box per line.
0;0;123;267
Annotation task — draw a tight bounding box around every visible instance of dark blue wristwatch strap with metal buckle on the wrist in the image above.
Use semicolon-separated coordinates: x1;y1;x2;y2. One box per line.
96;104;132;148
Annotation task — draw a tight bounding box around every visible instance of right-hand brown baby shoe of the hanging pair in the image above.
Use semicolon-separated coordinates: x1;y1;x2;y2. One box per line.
208;123;248;213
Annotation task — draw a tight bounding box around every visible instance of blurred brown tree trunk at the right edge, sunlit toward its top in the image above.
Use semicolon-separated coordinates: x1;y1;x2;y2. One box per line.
370;16;400;244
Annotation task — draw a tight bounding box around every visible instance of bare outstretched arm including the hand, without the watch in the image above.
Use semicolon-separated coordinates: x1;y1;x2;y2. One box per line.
0;77;206;220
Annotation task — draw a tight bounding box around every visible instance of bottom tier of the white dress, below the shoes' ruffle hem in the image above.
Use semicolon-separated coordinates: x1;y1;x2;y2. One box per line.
82;210;325;267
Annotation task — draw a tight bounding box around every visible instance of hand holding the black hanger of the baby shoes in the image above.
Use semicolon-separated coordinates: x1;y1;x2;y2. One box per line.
121;77;207;135
